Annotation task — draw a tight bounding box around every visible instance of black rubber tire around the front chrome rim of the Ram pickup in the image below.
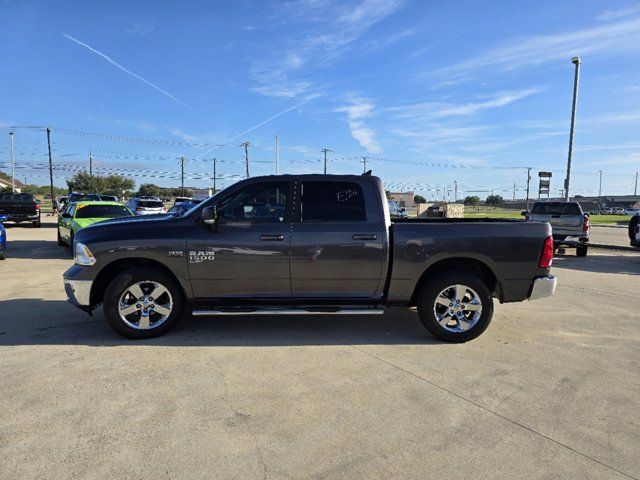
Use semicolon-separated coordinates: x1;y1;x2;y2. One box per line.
102;267;184;339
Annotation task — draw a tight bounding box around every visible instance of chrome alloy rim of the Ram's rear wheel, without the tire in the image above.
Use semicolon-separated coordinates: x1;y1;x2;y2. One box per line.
433;284;482;333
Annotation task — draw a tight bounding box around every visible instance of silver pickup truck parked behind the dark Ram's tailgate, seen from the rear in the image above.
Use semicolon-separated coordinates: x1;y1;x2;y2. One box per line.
522;202;589;257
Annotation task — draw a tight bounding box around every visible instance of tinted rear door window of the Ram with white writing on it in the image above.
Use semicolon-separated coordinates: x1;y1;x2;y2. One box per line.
301;181;367;222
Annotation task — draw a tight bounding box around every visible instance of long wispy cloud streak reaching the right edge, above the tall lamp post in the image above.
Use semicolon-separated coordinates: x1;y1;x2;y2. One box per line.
422;18;640;83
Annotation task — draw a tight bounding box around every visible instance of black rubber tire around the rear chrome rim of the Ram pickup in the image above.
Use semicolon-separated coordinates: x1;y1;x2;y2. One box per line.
416;271;493;343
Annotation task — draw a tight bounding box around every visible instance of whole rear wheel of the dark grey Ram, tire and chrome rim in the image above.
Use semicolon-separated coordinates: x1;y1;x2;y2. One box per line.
416;272;493;343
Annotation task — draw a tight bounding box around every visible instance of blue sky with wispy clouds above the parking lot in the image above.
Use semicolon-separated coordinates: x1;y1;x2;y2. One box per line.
0;0;640;198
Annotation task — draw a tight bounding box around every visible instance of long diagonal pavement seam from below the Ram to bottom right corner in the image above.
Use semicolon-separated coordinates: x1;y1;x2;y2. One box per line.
309;327;640;480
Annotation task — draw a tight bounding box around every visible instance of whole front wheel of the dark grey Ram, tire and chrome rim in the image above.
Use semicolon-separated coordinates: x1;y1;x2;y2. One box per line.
103;267;184;339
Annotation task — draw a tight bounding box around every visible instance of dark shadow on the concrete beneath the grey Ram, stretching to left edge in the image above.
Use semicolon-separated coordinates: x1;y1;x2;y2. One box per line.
0;299;446;347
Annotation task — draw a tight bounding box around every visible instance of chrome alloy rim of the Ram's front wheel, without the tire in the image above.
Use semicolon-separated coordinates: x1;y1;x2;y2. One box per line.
118;280;173;330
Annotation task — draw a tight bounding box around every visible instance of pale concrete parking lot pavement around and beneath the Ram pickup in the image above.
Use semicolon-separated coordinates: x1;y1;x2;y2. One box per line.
0;219;640;479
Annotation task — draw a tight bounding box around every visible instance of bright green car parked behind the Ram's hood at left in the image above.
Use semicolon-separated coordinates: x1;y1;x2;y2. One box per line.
58;202;133;246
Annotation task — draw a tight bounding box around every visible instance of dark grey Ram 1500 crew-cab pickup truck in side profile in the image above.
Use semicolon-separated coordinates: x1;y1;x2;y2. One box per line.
64;175;556;342
